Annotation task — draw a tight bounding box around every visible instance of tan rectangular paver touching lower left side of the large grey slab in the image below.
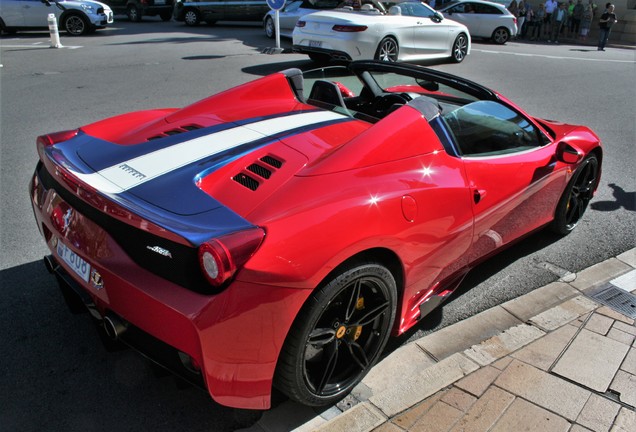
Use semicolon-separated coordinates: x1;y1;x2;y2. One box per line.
495;360;591;421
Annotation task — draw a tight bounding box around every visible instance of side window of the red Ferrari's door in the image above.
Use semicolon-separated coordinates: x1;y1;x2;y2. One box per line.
442;101;544;156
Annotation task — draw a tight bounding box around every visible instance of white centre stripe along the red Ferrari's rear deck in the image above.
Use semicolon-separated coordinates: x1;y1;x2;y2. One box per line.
71;111;350;194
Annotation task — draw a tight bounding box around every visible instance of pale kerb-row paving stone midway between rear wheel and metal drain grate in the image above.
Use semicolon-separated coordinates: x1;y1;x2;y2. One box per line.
464;324;545;366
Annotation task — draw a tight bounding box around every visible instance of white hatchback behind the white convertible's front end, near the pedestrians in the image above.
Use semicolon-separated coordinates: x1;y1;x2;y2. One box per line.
440;0;517;44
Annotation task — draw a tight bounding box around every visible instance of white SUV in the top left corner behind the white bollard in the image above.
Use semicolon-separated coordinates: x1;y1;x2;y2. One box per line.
0;0;113;36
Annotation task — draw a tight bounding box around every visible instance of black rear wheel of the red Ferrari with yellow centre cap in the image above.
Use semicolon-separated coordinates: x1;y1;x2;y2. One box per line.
274;263;397;406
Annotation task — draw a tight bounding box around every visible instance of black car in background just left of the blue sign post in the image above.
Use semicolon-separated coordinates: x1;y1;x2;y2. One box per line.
173;0;270;26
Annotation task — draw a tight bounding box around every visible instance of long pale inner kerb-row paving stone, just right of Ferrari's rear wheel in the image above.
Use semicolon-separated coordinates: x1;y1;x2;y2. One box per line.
369;354;479;417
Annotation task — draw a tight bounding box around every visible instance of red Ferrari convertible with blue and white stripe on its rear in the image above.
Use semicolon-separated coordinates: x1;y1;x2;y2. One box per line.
30;61;603;409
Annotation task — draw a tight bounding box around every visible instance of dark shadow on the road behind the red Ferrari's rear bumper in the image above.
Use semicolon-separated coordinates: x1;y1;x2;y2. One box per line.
0;261;262;432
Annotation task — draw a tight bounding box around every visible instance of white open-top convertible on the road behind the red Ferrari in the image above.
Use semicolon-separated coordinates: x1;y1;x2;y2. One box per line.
293;0;470;63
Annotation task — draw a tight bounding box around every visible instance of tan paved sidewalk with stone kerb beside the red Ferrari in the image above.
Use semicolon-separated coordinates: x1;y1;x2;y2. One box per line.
244;249;636;432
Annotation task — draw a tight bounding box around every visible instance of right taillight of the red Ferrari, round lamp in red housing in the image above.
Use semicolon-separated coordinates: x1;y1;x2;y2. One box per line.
199;228;265;287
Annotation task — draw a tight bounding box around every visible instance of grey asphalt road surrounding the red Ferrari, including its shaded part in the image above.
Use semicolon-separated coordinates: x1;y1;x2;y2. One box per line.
0;19;636;432
